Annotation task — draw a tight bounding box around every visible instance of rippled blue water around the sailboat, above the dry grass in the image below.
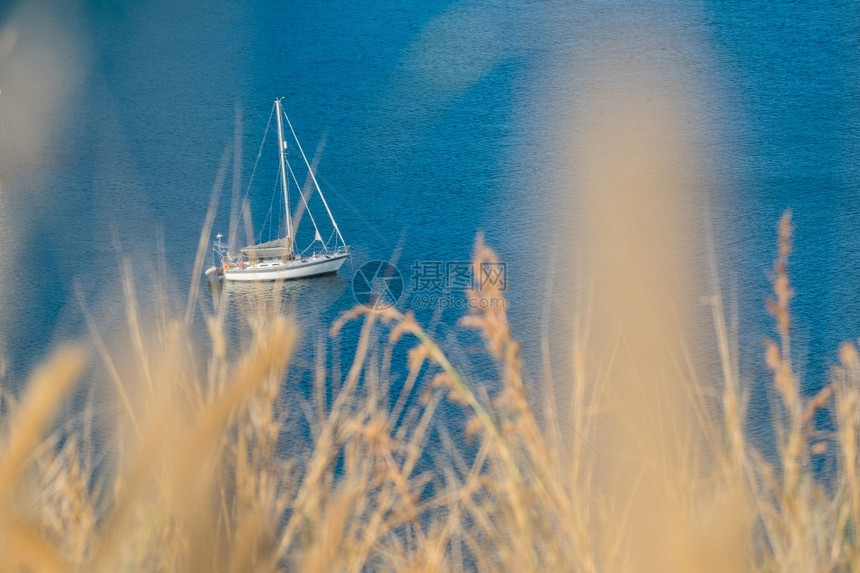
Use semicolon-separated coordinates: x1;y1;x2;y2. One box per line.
0;0;860;446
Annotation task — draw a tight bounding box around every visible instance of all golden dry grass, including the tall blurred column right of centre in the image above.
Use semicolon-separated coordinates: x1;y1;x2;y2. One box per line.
0;3;860;573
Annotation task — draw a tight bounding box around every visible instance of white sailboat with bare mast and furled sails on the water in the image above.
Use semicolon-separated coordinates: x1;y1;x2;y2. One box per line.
206;98;349;281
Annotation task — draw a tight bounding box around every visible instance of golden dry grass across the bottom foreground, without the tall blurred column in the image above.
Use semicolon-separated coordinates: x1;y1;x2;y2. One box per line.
0;211;860;571
